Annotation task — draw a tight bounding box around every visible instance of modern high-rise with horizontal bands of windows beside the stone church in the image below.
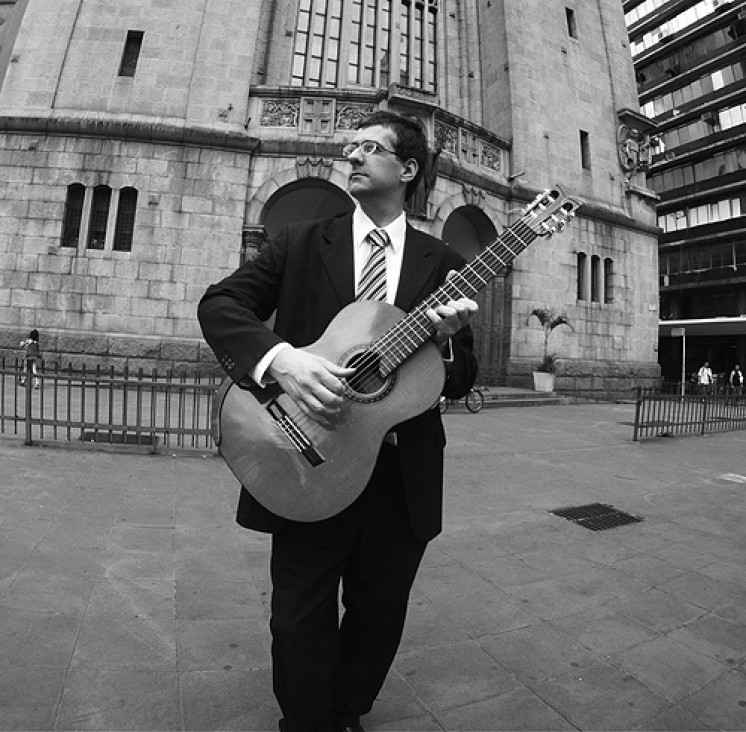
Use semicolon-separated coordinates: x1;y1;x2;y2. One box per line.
624;0;746;381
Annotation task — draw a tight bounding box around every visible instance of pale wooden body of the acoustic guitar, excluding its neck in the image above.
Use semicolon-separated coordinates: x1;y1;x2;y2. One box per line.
213;301;444;521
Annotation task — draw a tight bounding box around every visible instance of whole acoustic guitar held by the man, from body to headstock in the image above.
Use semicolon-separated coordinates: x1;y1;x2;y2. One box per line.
212;187;581;521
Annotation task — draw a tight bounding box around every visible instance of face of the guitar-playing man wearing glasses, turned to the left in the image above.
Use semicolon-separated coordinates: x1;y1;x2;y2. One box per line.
348;125;413;200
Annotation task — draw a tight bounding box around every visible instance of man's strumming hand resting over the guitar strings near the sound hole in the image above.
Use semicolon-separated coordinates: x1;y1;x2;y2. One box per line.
267;348;355;427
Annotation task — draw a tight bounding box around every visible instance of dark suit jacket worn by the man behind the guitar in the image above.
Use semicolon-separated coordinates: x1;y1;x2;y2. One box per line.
198;214;477;541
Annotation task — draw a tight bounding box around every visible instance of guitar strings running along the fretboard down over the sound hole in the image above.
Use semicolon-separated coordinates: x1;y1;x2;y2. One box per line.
342;217;536;389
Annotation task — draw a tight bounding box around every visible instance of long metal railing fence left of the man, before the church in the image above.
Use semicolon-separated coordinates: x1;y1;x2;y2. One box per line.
0;359;221;449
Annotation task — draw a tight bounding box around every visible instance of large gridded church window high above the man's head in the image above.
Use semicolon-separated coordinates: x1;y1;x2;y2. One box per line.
291;0;438;92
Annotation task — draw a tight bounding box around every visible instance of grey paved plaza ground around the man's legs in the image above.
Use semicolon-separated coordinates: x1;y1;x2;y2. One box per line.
0;404;746;732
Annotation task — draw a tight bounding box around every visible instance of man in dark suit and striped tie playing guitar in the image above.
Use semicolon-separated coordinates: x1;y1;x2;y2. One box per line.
199;112;477;732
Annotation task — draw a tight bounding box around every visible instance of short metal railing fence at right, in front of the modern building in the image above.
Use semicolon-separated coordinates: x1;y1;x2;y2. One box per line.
632;385;746;441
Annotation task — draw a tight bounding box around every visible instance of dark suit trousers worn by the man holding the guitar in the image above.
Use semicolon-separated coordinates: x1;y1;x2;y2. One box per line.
270;445;425;732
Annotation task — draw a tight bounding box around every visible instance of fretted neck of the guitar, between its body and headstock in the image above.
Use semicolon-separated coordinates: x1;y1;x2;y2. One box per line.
372;218;538;377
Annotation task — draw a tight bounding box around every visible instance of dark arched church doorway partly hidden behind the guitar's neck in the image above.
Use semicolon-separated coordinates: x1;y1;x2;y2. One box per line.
441;206;505;385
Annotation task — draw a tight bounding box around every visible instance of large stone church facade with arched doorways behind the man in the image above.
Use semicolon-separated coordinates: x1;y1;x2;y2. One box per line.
0;0;658;388
